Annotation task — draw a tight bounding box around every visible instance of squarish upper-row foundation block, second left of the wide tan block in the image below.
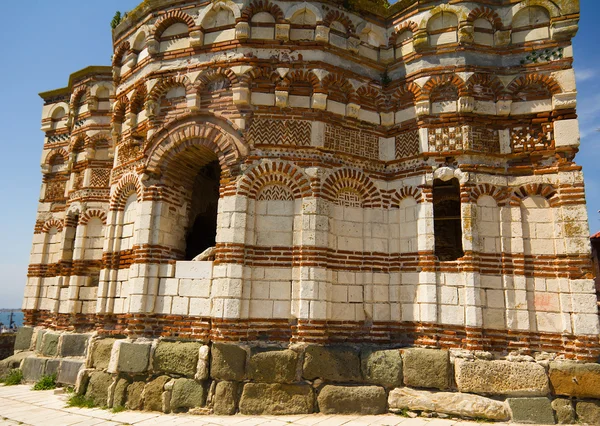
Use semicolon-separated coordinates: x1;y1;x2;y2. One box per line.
360;349;402;387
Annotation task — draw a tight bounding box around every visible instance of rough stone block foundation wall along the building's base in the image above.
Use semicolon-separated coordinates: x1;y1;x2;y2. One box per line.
11;329;600;424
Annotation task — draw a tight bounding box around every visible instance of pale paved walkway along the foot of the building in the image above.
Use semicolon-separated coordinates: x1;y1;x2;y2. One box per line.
0;385;548;426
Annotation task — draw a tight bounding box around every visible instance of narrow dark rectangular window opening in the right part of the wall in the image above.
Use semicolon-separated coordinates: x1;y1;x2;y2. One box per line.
433;178;464;262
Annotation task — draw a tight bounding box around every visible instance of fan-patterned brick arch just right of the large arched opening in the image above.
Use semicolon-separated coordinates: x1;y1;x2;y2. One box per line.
237;161;312;199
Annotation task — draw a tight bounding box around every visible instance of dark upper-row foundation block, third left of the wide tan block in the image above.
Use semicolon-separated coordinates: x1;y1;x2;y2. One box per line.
302;346;361;382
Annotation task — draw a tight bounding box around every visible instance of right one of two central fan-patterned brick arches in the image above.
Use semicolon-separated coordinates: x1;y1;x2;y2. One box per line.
322;169;383;208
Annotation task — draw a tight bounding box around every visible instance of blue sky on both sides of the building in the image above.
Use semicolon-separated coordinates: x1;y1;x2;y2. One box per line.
0;0;600;308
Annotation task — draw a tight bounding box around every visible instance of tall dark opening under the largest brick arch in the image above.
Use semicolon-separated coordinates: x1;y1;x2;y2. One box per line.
185;161;221;260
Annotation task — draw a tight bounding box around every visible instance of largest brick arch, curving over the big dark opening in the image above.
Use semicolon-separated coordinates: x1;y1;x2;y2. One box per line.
146;117;242;176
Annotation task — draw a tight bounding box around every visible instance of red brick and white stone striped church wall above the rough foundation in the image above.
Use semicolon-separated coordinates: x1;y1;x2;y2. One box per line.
12;0;600;422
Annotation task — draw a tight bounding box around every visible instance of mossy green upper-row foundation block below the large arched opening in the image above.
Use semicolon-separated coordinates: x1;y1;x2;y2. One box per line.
152;341;200;377
